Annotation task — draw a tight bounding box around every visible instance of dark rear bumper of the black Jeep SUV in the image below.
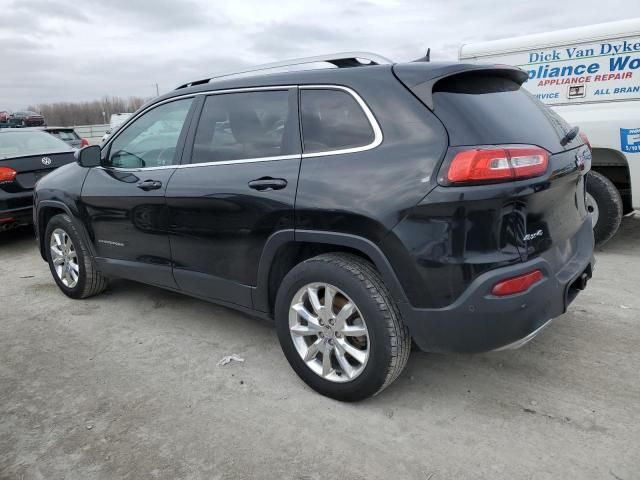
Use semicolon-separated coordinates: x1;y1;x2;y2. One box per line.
399;220;594;352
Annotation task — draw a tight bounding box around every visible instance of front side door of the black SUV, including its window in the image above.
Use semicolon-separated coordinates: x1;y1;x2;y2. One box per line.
82;98;194;288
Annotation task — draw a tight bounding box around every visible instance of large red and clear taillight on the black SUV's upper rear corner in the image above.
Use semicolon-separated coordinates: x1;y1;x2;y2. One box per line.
447;147;549;183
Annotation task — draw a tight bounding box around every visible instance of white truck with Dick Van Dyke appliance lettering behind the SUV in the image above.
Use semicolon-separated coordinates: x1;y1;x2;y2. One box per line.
459;18;640;244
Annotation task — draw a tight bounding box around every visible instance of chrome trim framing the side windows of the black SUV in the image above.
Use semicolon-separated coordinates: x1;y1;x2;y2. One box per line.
101;84;383;172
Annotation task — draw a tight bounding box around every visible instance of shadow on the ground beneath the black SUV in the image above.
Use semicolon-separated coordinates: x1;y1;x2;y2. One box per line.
104;274;573;412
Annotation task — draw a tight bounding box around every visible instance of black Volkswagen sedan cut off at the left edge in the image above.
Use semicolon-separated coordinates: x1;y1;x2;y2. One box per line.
0;128;75;231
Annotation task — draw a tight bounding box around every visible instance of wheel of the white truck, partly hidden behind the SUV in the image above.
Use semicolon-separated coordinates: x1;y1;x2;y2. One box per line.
587;170;622;246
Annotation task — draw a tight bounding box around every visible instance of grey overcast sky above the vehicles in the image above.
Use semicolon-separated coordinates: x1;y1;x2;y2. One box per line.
0;0;637;110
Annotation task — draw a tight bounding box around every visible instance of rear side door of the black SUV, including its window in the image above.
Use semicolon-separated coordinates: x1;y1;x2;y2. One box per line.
166;87;301;307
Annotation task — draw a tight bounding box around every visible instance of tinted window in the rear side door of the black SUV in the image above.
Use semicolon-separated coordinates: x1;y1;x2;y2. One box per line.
191;90;298;163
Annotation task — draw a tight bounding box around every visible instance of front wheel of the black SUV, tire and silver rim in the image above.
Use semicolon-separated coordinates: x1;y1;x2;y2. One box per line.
44;214;107;299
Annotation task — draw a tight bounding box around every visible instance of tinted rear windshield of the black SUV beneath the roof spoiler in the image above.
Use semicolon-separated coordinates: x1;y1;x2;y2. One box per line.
433;72;581;153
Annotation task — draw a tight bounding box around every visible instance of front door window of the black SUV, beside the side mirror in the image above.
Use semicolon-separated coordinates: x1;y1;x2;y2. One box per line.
109;98;193;168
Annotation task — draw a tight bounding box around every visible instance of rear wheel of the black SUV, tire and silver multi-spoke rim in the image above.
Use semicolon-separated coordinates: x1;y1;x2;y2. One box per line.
275;253;411;402
